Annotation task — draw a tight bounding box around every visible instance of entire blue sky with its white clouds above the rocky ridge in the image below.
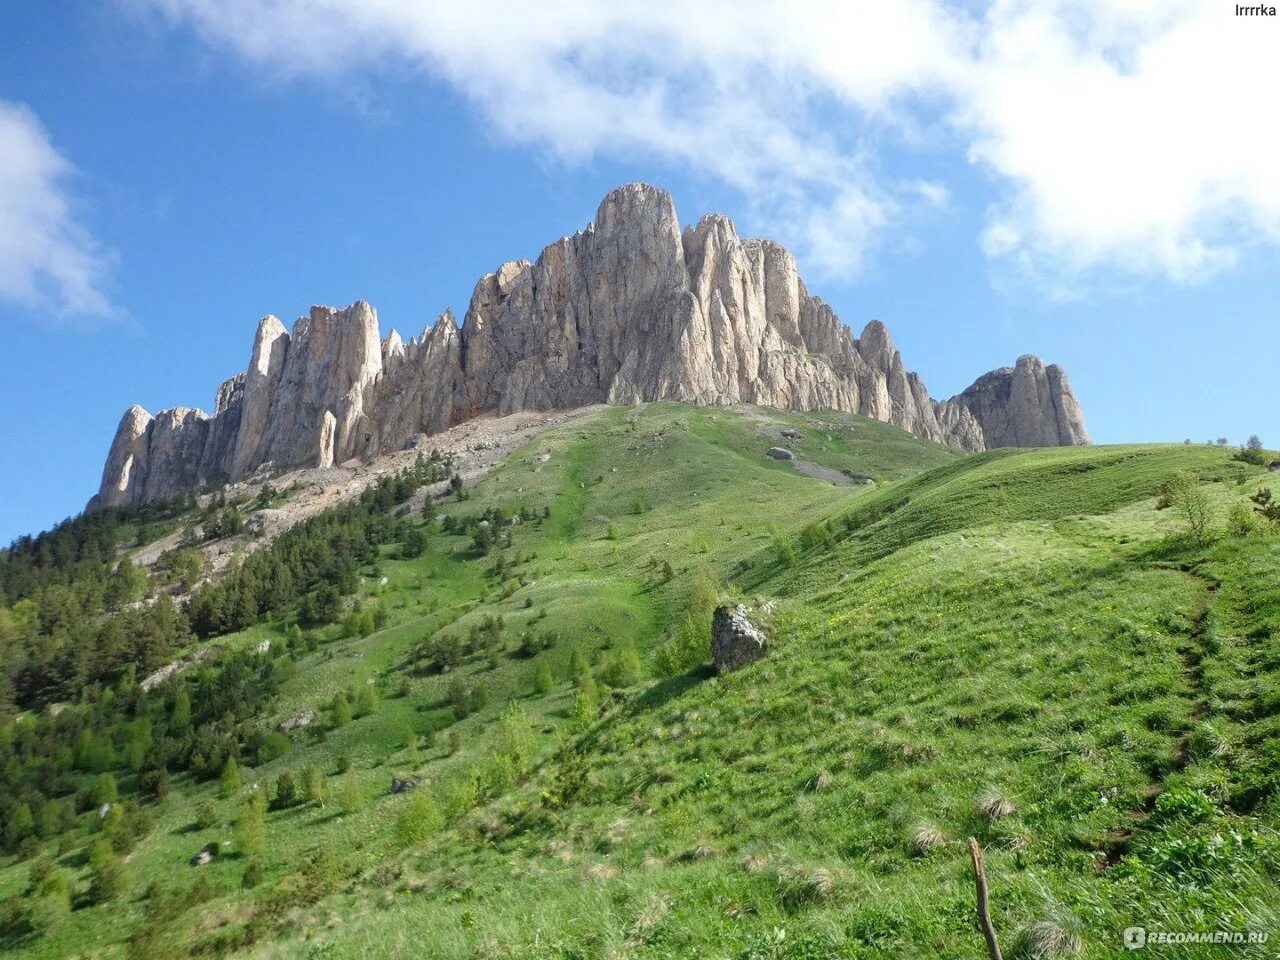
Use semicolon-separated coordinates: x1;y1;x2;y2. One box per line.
0;0;1280;541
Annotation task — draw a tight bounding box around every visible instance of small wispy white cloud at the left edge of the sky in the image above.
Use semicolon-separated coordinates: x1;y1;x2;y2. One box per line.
0;100;115;316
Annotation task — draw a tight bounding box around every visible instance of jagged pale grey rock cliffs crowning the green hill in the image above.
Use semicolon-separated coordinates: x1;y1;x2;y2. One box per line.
90;183;1088;508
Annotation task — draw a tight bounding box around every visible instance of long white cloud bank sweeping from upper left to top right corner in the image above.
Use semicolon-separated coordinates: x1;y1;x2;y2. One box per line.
120;0;1280;282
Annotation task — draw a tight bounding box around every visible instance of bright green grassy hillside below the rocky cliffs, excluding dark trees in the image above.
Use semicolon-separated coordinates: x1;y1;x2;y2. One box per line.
0;404;1280;960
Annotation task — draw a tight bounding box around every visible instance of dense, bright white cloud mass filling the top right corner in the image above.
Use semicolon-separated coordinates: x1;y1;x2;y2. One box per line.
956;0;1280;280
